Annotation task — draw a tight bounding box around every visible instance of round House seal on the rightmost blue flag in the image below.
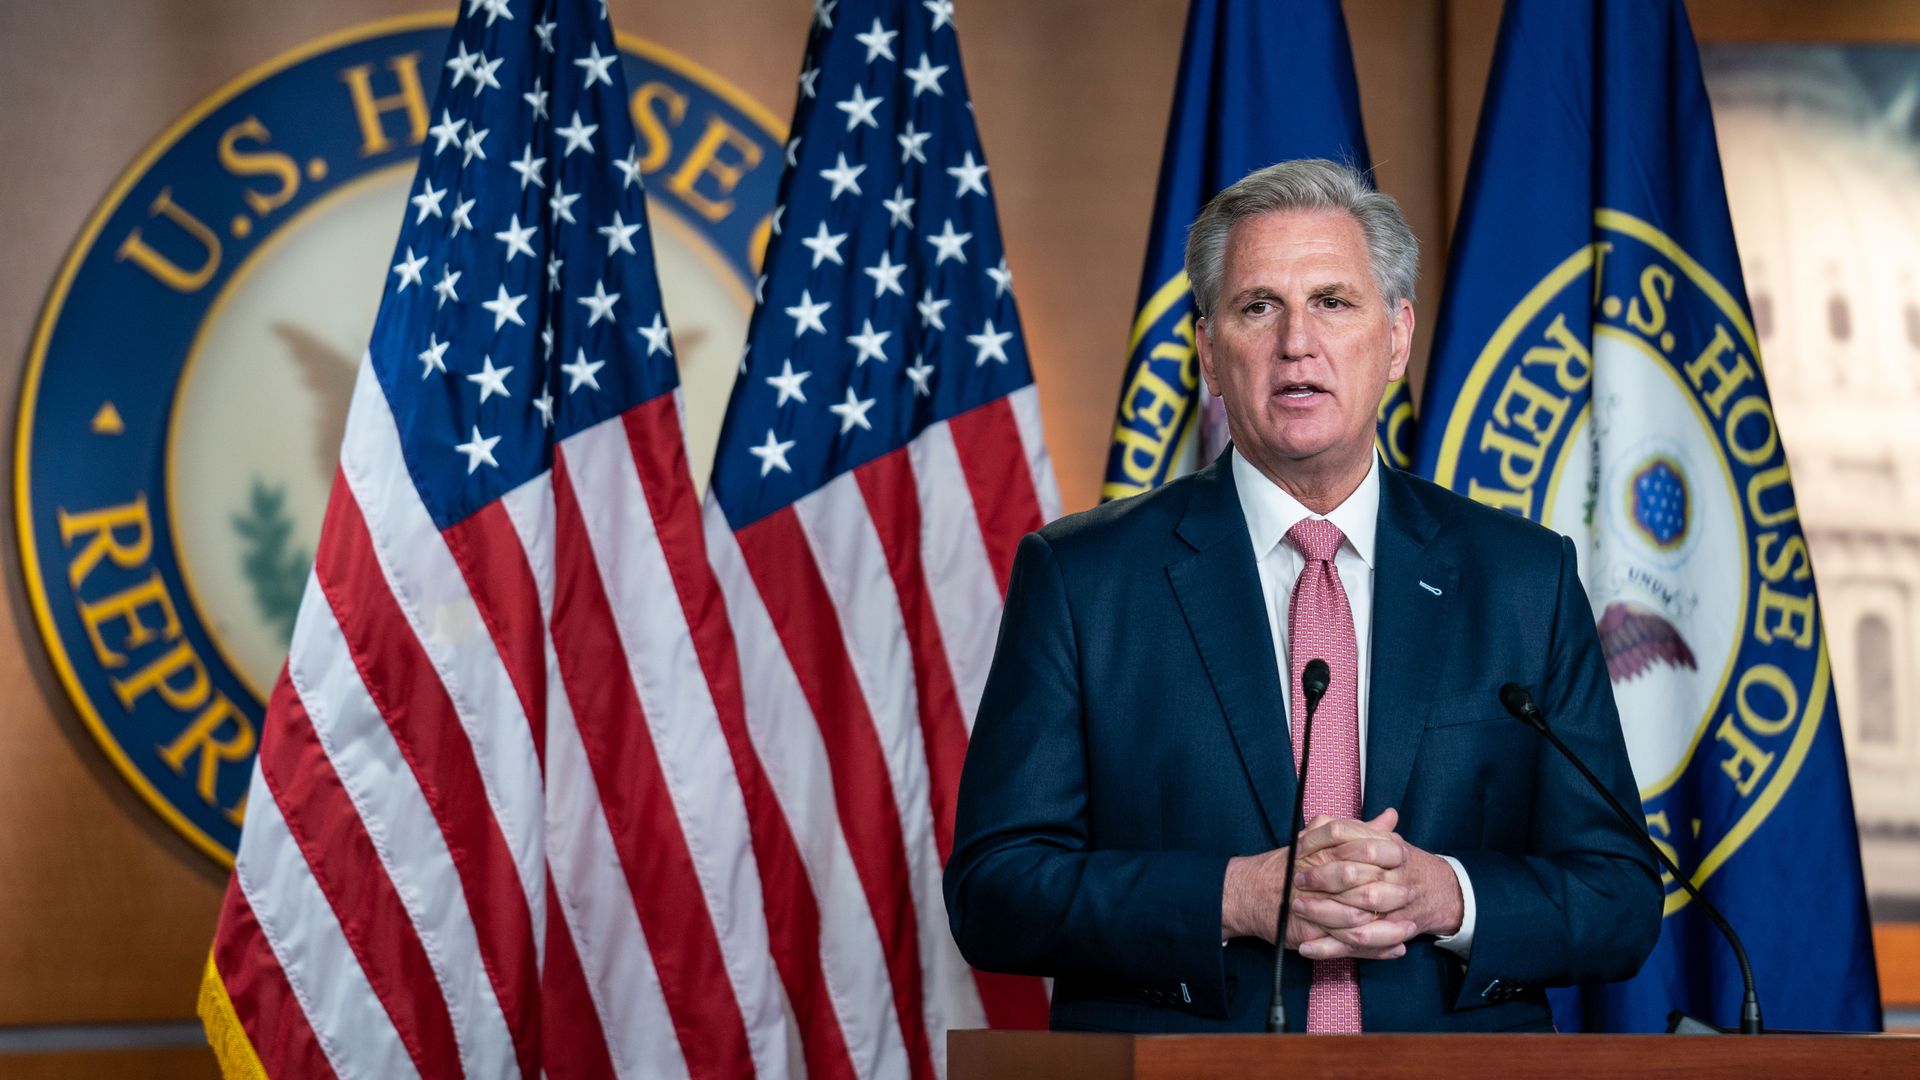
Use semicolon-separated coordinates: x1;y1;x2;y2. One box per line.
1434;209;1830;913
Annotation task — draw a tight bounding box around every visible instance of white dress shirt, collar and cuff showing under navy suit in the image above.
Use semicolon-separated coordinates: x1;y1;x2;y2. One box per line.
1233;450;1476;957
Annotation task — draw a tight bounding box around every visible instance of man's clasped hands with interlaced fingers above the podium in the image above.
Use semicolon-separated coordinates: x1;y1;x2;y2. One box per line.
1221;809;1463;961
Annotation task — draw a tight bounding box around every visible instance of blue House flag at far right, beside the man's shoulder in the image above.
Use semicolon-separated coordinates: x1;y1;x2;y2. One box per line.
1419;0;1880;1032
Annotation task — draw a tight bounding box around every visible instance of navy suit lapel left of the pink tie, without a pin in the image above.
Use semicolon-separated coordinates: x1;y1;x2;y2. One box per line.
1167;454;1294;844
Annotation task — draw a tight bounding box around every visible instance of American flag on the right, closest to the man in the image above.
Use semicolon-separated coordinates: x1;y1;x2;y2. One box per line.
707;0;1060;1076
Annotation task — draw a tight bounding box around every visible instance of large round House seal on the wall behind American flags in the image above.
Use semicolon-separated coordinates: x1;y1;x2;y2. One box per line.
15;15;785;863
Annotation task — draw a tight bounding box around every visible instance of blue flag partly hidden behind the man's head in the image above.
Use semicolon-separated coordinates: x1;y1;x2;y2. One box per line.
1100;0;1411;500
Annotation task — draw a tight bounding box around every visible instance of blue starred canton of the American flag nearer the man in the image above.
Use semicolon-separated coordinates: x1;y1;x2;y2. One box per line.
712;0;1033;528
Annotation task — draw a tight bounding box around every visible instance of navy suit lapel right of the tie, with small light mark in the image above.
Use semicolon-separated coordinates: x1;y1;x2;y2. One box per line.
1361;467;1459;821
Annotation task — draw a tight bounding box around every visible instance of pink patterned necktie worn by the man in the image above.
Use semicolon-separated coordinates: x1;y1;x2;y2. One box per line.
1286;517;1359;1034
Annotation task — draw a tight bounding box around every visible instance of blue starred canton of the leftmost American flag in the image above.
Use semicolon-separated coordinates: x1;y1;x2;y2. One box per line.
369;0;680;528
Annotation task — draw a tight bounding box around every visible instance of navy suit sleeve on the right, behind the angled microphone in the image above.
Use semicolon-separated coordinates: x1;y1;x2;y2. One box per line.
1450;538;1663;1007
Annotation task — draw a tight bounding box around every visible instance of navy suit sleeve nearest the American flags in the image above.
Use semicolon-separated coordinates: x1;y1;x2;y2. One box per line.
945;534;1227;1015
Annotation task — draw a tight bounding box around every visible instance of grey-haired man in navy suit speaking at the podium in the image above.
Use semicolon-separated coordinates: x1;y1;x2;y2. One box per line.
947;161;1663;1032
